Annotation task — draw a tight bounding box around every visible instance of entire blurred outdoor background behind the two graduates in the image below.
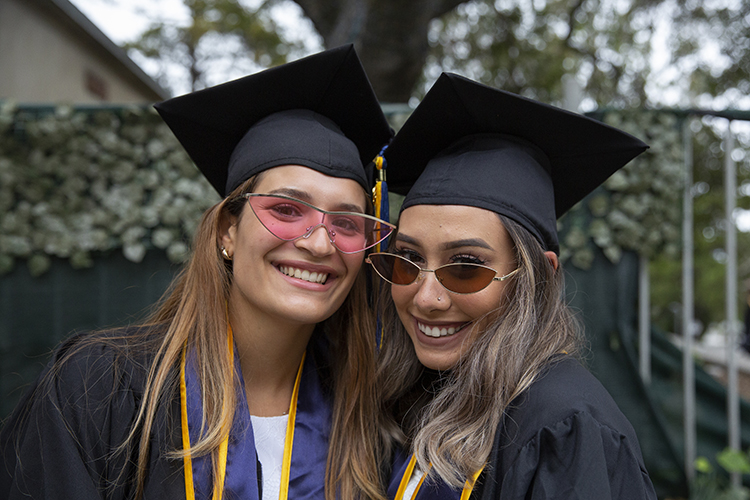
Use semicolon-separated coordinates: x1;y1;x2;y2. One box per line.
0;0;750;499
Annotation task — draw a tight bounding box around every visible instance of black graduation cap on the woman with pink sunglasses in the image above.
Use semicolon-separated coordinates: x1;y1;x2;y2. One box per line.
155;45;392;196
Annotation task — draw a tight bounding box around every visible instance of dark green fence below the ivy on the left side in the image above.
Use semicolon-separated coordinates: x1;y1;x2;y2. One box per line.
0;250;179;418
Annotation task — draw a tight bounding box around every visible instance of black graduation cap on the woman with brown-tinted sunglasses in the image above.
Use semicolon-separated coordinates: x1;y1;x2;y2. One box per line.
385;73;648;252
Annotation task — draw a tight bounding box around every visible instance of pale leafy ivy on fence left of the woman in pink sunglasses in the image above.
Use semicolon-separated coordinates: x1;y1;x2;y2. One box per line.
0;102;219;276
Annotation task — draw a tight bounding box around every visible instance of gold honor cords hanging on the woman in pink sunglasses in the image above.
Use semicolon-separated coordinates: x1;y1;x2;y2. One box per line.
180;325;307;500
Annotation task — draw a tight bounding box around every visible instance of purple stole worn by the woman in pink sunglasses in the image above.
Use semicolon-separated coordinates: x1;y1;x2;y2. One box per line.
185;347;331;500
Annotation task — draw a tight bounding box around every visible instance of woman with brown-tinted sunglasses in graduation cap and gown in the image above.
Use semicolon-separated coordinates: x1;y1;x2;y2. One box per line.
368;74;656;500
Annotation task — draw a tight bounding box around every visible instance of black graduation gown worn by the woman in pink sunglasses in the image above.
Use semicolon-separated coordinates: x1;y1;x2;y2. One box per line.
0;332;185;500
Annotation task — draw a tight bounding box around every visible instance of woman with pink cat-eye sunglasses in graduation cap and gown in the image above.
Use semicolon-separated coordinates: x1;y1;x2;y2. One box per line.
0;46;393;500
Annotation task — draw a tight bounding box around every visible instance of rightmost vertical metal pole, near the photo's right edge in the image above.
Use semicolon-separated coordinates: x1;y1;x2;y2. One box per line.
724;121;740;486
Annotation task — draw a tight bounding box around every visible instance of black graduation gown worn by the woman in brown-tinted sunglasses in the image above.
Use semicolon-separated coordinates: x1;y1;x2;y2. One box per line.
471;356;656;500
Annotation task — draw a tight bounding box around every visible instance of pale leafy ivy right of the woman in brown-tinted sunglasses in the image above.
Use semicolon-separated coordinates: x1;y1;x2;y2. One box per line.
558;111;685;269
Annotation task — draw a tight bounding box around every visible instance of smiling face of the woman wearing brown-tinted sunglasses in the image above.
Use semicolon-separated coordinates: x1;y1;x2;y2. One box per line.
391;205;516;370
